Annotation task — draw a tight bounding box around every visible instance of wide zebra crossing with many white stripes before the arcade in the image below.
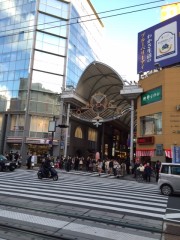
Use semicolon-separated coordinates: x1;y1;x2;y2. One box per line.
0;169;168;219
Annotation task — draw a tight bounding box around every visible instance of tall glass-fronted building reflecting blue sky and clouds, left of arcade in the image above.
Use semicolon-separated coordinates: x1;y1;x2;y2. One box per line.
0;0;103;158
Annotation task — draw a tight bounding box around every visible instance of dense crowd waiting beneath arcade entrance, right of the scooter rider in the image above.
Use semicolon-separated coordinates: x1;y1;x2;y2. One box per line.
55;156;161;182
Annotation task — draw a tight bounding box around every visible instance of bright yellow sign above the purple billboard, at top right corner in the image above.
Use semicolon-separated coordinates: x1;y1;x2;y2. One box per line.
161;2;180;22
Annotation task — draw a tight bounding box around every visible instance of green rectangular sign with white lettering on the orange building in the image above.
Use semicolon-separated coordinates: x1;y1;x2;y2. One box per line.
141;87;162;106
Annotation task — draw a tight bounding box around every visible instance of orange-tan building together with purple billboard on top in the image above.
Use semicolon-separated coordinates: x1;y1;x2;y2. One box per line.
136;12;180;163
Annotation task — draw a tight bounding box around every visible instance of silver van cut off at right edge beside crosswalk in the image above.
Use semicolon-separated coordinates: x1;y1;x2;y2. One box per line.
158;163;180;196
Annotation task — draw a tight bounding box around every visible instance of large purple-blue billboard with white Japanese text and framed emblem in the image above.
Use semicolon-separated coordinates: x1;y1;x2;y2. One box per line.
137;15;180;73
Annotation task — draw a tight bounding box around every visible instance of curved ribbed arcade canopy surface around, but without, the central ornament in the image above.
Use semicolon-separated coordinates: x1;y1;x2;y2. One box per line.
62;61;134;128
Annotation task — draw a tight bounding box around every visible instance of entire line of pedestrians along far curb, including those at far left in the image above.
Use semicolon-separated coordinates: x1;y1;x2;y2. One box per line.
5;151;161;182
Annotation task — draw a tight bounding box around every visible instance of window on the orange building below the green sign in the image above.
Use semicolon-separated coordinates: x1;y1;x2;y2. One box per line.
140;113;162;136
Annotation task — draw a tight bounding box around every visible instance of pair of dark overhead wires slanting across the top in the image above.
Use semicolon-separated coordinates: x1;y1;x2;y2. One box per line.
1;0;165;37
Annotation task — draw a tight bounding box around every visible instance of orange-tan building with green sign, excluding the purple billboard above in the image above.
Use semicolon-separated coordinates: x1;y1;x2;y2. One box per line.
136;66;180;162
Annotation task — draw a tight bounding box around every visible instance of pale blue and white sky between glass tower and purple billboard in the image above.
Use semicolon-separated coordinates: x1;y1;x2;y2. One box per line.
91;0;178;81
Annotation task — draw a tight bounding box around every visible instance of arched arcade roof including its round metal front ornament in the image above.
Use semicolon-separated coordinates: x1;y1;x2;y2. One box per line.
62;61;134;128
